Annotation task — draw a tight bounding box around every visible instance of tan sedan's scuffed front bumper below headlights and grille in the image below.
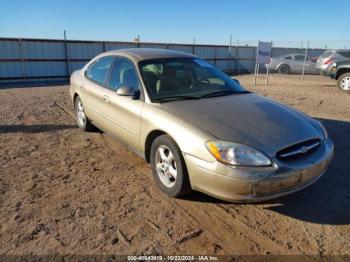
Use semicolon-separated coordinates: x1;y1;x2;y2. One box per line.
184;139;334;202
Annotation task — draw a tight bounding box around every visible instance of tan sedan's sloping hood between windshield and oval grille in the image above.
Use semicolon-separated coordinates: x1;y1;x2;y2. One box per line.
161;93;322;156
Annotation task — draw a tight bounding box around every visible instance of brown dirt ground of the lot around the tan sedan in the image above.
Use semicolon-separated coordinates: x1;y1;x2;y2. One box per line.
0;75;350;256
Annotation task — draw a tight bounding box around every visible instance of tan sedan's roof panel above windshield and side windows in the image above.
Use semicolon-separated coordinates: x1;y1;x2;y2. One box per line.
102;48;197;62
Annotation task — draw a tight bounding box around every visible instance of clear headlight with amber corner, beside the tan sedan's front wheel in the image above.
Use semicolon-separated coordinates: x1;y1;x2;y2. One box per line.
206;141;272;166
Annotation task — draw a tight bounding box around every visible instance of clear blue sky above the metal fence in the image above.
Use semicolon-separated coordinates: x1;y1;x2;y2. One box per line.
0;0;350;48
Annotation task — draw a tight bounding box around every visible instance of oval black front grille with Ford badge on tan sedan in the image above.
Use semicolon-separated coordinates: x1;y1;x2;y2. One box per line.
277;139;321;161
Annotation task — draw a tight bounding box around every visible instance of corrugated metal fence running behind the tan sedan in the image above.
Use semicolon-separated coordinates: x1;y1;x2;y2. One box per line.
0;38;324;82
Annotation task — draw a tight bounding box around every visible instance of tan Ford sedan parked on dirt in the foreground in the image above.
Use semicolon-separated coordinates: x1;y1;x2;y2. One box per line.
70;48;333;202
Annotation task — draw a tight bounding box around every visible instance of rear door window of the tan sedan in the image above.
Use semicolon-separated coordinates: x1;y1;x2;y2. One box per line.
86;56;114;85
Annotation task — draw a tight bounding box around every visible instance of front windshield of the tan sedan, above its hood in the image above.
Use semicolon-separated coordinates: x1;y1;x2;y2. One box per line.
139;58;248;102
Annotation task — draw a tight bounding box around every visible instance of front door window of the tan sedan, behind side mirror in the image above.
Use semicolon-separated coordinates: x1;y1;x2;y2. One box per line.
108;57;139;90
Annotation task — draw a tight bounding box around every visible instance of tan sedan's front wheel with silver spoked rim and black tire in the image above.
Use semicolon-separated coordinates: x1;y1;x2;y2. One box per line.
151;135;192;197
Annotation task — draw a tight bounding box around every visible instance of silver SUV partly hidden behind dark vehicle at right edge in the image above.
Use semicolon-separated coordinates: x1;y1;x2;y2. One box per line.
315;49;350;75
